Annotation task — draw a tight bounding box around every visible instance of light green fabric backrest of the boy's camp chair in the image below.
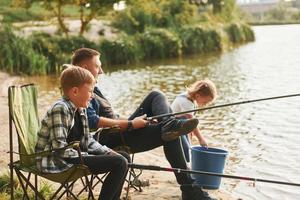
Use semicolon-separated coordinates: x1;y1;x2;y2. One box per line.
8;84;39;166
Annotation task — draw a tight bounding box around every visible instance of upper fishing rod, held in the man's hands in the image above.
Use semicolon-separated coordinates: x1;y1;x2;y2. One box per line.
146;94;300;121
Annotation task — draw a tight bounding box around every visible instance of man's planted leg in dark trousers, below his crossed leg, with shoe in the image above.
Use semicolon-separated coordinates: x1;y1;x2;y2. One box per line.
124;126;212;200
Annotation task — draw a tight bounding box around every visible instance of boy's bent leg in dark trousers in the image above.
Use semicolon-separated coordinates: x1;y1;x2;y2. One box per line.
65;152;128;200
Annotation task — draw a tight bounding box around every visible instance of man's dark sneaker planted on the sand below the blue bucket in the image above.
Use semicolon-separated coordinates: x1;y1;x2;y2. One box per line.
182;187;217;200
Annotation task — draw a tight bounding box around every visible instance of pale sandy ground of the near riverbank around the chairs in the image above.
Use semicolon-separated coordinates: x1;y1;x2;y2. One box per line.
0;72;237;200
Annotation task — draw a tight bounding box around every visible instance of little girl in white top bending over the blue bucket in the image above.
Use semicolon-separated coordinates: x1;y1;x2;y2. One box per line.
171;79;217;162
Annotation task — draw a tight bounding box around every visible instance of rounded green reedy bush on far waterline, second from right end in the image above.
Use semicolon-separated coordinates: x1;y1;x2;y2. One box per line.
180;26;221;54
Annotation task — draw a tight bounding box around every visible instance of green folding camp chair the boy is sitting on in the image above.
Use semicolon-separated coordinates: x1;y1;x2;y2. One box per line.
8;84;94;199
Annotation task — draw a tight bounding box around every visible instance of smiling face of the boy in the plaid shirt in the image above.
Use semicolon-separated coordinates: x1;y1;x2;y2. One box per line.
69;83;94;108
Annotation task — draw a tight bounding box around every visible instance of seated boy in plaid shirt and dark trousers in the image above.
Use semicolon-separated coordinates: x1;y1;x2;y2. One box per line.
35;66;128;200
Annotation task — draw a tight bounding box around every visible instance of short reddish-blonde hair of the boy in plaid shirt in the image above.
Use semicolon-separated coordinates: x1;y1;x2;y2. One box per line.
60;65;95;94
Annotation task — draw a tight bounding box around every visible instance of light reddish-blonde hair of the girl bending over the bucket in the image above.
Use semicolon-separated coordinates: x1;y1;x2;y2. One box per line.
187;79;217;101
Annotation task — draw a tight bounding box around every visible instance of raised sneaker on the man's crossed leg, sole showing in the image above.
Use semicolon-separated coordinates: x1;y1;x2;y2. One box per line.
161;118;199;141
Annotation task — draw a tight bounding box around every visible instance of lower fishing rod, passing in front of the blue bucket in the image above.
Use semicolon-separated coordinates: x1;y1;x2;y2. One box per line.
128;163;300;187
